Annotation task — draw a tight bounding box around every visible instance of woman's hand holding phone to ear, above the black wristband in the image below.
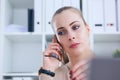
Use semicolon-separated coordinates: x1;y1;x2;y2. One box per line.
43;36;61;71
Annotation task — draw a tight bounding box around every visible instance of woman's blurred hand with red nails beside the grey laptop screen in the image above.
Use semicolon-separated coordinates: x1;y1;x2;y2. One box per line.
70;61;88;80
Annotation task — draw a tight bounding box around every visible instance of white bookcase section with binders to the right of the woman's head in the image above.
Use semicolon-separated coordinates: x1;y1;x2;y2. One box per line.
86;0;120;57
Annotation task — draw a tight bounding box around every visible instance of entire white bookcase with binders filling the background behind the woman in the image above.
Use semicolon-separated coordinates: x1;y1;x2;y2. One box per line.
0;0;120;80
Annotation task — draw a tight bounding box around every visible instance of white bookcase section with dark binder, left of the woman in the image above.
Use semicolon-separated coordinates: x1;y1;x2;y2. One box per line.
0;0;44;80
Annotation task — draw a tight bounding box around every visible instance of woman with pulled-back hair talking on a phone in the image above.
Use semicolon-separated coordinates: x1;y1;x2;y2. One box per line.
40;7;93;80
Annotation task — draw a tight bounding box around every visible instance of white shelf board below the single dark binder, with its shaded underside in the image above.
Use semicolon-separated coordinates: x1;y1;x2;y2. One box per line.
5;32;42;42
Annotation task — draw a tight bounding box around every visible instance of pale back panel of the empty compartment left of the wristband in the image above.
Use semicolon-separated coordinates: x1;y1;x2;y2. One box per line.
11;42;42;72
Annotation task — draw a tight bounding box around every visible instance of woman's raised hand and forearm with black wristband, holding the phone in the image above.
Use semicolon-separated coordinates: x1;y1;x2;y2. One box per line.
39;38;61;80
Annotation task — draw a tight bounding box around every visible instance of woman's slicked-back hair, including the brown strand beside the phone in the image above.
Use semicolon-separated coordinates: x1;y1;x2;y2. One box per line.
52;6;87;64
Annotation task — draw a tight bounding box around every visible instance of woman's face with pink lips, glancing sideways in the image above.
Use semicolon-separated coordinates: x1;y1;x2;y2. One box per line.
53;10;90;56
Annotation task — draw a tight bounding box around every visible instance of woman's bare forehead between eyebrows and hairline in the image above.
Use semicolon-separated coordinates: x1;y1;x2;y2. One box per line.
54;10;83;27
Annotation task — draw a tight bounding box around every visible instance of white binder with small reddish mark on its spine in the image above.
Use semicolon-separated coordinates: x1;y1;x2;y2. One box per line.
104;0;117;32
